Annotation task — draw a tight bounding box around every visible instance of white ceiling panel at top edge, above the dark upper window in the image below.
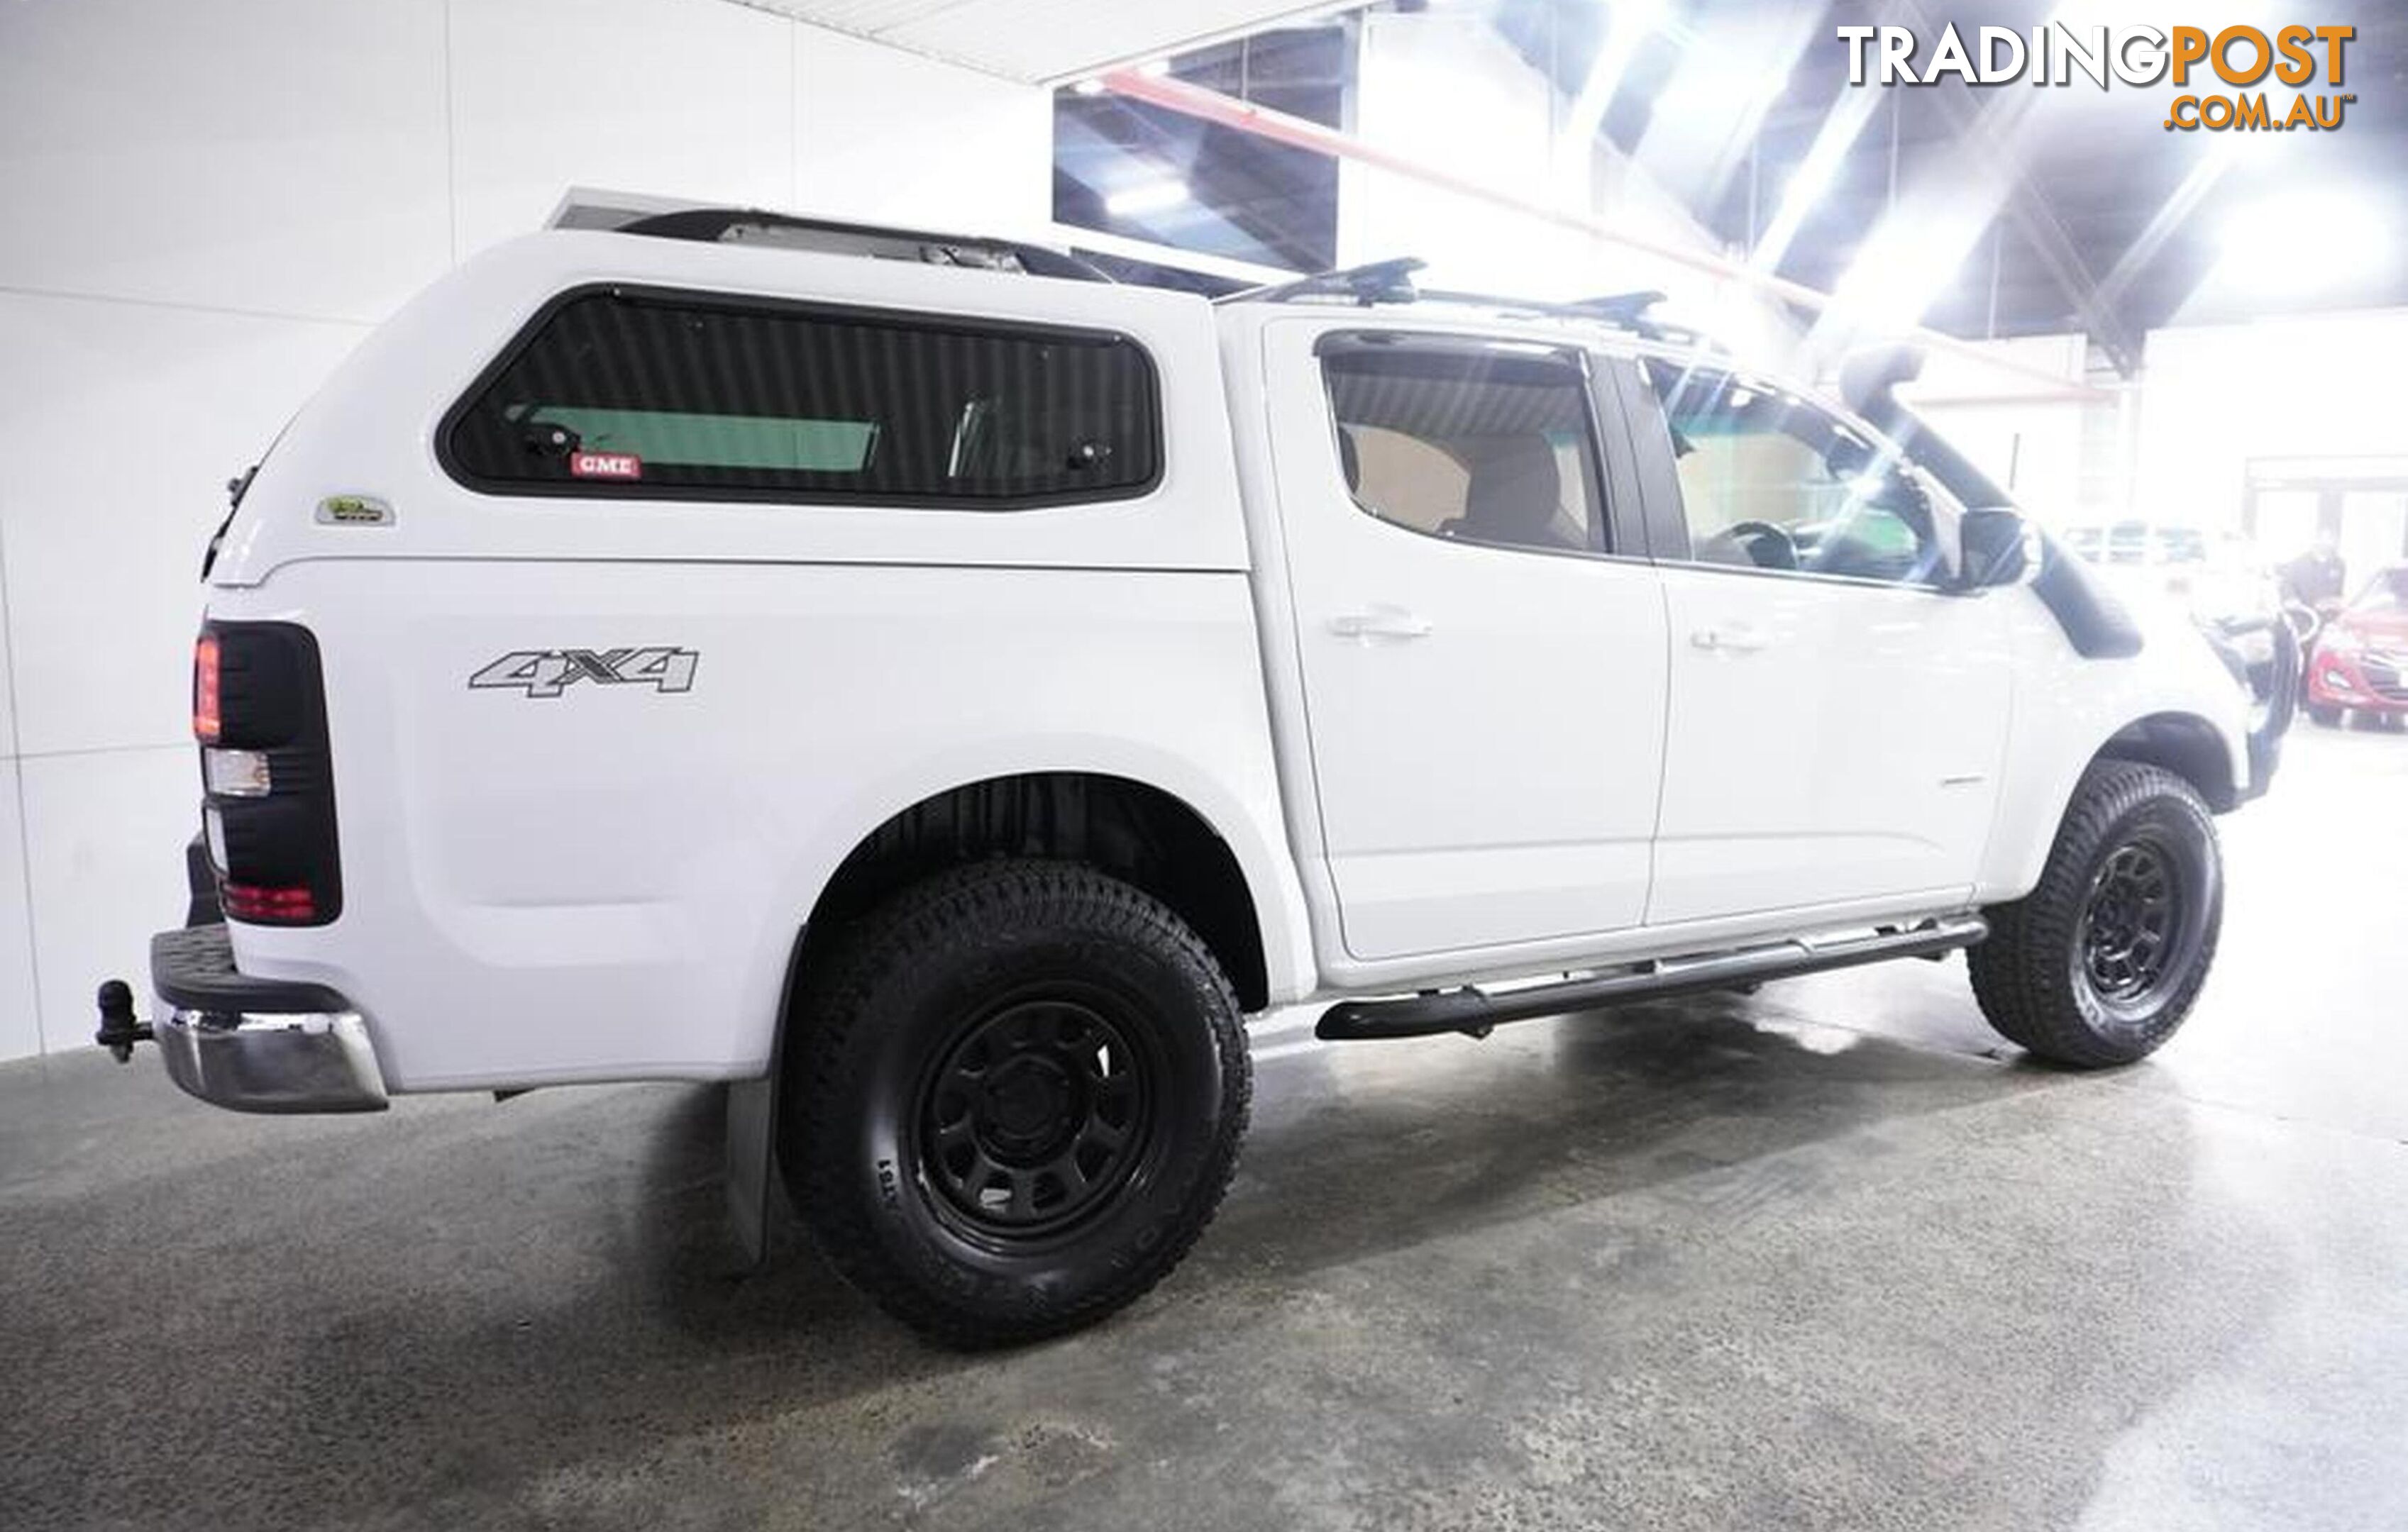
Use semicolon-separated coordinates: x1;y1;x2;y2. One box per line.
737;0;1339;84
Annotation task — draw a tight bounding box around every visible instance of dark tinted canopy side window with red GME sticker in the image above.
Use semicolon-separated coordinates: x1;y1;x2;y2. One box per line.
443;289;1161;509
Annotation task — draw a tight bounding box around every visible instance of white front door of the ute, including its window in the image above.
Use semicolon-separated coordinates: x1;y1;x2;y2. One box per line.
1633;361;2013;925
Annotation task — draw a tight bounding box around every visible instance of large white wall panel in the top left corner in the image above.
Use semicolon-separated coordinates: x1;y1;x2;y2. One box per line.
0;0;453;318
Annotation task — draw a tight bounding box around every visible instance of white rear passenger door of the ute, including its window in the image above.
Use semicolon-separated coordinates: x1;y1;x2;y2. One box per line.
1266;325;1667;959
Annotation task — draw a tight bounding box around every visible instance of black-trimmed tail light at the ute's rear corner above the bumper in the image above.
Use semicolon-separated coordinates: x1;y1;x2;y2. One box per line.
193;621;342;925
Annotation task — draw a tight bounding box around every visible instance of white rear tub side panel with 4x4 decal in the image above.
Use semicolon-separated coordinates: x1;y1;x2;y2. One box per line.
212;561;1310;1089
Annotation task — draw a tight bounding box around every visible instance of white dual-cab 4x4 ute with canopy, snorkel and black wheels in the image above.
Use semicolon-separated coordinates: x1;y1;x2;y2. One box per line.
101;212;2287;1344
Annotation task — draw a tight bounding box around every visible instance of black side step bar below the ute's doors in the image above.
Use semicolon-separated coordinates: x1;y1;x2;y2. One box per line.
1313;916;1989;1040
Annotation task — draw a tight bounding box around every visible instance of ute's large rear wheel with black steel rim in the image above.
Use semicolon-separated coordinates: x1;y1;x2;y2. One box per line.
778;860;1252;1346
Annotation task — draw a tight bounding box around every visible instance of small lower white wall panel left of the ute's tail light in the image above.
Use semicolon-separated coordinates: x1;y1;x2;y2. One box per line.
17;744;200;1067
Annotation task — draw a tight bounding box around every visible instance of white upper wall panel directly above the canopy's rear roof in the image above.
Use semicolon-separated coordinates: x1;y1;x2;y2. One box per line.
451;0;795;255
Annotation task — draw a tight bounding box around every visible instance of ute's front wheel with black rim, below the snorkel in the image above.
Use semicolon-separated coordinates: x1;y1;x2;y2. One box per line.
1967;761;2225;1067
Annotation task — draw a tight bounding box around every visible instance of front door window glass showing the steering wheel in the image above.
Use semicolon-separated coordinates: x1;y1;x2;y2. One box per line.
1647;361;1945;585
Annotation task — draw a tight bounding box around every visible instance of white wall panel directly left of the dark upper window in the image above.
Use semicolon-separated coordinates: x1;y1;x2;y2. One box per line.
795;26;1052;233
